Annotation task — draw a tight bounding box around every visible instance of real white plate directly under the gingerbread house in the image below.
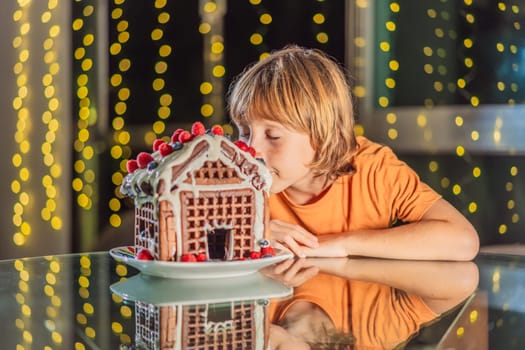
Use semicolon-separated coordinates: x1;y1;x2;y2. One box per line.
109;247;293;279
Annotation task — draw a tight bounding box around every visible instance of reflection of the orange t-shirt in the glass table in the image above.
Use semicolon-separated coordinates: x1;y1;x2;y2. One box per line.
270;274;439;349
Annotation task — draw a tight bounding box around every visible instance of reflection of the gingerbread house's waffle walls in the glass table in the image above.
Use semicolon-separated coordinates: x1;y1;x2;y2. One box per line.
135;300;269;350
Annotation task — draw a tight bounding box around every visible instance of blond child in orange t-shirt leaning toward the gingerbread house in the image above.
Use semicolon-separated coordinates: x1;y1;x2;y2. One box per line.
228;46;479;260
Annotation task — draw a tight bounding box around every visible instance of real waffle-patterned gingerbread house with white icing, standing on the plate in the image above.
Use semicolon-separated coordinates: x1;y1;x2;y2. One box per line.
121;134;271;261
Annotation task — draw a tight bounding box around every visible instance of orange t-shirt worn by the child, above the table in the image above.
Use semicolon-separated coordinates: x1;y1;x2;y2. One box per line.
270;137;441;235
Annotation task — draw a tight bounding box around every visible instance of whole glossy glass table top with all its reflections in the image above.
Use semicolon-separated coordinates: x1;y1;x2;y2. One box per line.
0;252;525;350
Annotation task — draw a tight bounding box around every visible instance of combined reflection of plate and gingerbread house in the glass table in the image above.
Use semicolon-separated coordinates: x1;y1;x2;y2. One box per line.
110;273;293;349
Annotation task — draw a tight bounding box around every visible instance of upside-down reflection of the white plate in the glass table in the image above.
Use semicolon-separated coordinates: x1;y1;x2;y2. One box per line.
110;273;292;305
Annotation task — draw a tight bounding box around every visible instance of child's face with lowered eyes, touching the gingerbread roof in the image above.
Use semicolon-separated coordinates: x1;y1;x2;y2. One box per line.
237;118;315;193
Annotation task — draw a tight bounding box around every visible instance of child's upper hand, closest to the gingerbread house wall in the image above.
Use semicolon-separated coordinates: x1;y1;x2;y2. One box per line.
270;220;319;258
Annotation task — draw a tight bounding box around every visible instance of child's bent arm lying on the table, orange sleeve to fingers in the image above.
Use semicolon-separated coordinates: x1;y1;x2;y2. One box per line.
278;199;479;261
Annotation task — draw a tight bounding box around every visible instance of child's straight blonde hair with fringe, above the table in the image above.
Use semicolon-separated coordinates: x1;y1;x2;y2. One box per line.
228;45;357;179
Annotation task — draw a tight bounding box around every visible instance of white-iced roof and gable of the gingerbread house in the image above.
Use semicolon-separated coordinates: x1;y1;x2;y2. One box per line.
120;134;271;204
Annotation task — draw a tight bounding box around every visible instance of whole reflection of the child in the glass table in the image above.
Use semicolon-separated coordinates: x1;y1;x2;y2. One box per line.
262;259;478;349
